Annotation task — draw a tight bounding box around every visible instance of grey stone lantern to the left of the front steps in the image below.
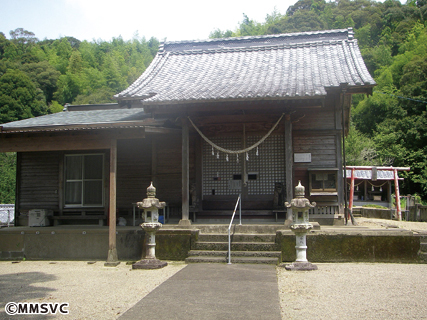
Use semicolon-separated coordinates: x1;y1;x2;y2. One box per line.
132;182;167;269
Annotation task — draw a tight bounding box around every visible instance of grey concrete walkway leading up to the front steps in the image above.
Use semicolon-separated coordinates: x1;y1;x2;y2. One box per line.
119;264;281;320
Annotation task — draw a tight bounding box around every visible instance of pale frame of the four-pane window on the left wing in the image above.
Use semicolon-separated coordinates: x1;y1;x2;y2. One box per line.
63;153;105;208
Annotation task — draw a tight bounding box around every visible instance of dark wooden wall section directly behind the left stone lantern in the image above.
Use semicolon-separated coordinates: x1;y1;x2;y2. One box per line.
117;134;182;212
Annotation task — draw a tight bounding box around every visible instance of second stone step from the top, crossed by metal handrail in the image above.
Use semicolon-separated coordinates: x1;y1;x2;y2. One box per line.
192;241;279;251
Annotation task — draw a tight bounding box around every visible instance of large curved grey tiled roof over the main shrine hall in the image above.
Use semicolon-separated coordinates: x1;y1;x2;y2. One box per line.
115;29;375;105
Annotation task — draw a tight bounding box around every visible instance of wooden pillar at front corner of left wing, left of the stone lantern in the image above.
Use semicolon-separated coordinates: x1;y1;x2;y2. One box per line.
104;139;120;267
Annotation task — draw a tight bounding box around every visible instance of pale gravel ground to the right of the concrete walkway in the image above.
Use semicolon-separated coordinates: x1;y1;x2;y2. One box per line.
277;263;427;320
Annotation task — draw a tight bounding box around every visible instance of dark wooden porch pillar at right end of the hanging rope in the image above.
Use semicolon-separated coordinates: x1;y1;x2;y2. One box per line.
285;114;294;223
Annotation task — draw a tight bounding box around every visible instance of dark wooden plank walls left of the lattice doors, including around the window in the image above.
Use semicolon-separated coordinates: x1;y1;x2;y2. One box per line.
17;134;184;219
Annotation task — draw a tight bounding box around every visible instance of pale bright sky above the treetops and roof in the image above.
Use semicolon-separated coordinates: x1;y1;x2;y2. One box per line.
0;0;297;41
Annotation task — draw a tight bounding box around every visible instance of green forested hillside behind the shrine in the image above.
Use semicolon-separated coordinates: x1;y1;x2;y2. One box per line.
0;0;427;203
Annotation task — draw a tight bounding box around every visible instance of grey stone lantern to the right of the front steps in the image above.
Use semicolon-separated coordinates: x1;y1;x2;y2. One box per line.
285;181;317;271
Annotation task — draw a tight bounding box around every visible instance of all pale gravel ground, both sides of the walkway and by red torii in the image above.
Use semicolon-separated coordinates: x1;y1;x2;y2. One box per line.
0;218;427;320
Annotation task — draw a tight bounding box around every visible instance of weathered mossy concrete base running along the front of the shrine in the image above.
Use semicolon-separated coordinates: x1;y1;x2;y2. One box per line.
0;222;427;264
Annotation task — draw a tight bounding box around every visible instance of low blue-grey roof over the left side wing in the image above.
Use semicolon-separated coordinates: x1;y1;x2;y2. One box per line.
0;108;147;132
